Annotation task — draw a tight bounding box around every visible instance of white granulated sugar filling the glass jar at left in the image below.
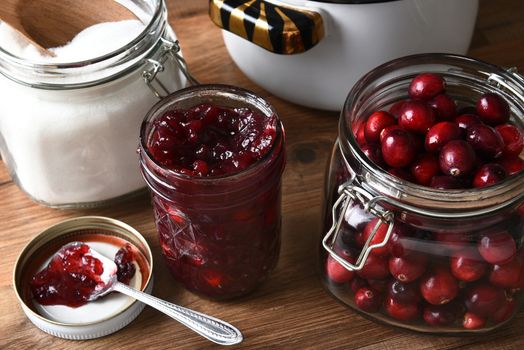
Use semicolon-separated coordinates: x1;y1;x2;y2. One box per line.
0;20;185;206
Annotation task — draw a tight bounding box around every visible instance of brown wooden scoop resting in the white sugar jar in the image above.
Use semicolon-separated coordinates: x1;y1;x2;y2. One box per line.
0;0;137;55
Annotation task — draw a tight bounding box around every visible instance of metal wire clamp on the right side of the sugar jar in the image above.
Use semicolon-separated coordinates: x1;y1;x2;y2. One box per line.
142;38;198;99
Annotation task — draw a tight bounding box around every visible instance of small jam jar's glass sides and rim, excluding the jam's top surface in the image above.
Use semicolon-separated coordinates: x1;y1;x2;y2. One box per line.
139;85;286;299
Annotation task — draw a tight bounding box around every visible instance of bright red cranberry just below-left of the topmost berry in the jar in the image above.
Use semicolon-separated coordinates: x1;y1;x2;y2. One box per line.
398;101;437;134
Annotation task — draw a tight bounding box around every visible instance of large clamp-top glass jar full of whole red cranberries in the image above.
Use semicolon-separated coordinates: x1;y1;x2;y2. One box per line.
320;54;524;333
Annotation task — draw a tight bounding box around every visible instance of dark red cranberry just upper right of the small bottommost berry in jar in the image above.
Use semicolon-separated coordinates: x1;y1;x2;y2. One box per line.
465;283;506;317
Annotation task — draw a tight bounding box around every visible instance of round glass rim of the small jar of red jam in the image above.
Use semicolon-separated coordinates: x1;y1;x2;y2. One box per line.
139;84;284;187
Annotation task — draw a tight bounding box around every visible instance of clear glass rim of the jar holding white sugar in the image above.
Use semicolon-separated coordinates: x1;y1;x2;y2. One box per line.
0;0;167;90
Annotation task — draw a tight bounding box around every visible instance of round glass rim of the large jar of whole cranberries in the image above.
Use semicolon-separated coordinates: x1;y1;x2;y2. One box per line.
339;53;524;216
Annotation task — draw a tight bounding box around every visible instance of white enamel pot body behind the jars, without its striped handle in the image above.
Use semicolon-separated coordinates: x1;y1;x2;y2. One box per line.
210;0;478;110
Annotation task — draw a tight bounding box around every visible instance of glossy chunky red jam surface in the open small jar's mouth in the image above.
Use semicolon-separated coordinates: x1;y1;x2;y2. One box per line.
149;104;277;176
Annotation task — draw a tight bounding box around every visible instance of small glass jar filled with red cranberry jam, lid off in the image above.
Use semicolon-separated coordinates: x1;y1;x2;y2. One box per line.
139;85;286;299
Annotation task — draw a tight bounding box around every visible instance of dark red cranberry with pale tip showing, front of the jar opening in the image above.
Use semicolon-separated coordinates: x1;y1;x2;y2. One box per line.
439;140;476;176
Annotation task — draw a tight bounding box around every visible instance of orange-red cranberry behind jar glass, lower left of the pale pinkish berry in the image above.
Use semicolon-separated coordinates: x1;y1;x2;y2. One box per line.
450;249;488;282
